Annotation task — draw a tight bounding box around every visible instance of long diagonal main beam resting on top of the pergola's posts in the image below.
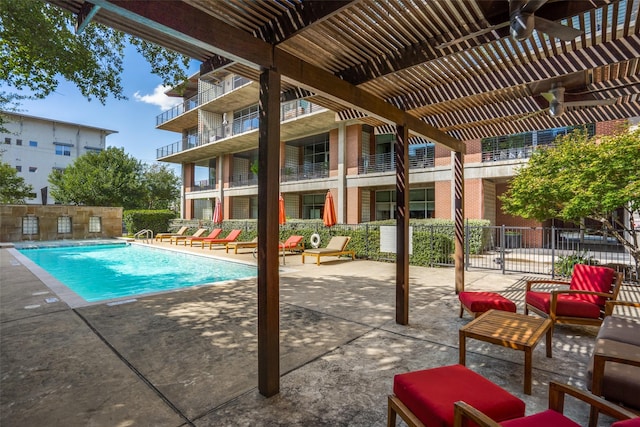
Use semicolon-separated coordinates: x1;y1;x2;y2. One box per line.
90;0;465;152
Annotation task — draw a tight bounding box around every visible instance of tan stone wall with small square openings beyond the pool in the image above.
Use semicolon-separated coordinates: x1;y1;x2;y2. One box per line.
0;205;122;242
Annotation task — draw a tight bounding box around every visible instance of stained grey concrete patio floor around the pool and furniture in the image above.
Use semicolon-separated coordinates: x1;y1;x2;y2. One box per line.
0;243;638;427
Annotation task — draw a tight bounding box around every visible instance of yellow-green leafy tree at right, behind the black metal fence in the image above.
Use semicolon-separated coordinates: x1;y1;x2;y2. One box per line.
501;125;640;268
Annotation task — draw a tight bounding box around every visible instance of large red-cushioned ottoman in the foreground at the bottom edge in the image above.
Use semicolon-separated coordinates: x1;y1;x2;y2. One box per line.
387;365;524;427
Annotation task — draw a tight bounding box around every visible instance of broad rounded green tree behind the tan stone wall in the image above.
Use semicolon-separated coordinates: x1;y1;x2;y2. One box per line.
49;147;146;209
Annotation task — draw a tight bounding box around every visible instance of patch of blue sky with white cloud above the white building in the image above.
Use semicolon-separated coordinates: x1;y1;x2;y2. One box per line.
6;44;199;164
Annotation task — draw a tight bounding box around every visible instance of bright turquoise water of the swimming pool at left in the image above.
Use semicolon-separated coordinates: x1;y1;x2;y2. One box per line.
20;244;257;302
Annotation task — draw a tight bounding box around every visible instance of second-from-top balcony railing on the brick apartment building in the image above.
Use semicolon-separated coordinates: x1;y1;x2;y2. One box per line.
156;101;326;159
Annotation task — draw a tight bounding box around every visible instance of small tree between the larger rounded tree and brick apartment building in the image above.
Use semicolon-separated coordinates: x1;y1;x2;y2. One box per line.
142;164;180;209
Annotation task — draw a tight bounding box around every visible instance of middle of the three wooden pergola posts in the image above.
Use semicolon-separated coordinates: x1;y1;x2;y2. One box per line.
394;125;409;325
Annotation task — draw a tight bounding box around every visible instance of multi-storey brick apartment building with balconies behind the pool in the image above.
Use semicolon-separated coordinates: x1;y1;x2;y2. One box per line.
156;72;613;226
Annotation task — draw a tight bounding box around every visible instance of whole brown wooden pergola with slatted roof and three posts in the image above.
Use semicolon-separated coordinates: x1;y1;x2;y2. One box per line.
49;0;640;396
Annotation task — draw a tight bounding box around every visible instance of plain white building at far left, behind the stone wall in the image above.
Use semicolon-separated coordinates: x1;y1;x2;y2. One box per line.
0;112;116;205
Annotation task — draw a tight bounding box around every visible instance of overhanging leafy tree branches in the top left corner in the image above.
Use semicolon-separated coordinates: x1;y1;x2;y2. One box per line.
0;0;189;117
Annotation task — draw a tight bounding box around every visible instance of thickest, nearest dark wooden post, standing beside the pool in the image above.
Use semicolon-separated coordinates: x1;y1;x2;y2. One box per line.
258;70;280;397
